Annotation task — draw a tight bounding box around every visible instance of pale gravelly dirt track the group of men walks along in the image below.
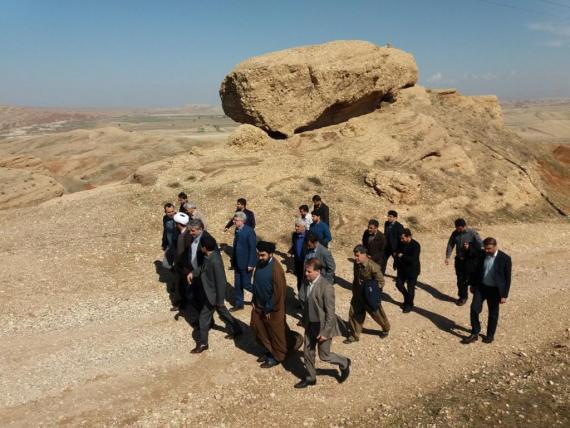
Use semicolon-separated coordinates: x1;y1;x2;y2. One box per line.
0;186;570;426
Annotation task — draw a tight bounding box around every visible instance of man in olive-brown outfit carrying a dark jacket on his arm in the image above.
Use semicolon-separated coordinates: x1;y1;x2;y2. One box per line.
343;245;390;344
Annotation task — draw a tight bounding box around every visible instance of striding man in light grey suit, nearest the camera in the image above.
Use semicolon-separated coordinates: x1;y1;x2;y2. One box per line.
295;258;350;388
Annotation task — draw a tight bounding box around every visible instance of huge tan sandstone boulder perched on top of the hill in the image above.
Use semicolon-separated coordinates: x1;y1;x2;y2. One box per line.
220;41;418;137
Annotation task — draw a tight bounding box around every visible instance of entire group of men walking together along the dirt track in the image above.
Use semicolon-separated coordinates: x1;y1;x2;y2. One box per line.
162;193;511;388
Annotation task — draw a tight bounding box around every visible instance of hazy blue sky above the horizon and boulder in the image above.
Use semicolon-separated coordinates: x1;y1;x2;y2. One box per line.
0;0;570;107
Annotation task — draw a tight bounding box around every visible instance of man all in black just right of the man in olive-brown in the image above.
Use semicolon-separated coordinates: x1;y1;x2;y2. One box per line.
395;229;421;313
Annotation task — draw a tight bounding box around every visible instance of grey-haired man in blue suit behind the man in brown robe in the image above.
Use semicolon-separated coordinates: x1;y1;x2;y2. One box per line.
230;211;257;312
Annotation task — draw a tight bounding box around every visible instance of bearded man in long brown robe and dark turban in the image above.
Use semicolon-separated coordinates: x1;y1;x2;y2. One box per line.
250;241;302;369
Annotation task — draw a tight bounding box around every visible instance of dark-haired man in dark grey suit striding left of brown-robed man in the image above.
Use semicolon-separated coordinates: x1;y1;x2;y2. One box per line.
188;236;242;354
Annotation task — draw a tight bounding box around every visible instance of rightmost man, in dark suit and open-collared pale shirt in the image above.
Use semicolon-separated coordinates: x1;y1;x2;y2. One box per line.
462;238;512;344
